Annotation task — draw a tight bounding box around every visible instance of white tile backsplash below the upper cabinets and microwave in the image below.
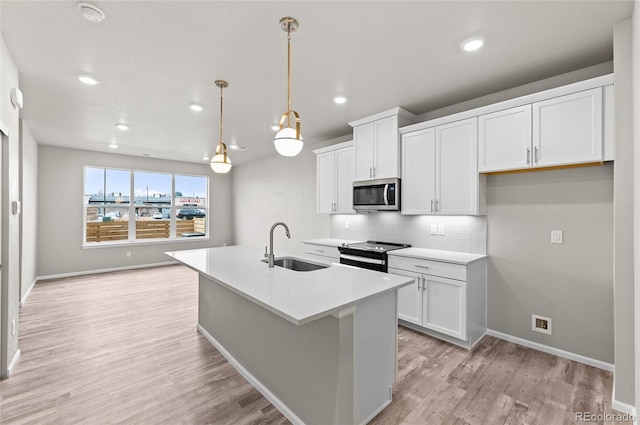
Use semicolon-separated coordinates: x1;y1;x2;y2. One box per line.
329;212;487;254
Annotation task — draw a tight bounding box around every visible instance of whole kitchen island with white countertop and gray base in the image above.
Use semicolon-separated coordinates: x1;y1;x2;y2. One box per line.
167;246;413;425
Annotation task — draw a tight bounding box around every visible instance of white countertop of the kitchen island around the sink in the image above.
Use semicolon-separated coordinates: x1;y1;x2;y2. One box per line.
166;246;413;325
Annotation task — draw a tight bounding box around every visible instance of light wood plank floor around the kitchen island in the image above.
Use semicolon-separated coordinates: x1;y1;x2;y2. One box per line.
0;266;612;425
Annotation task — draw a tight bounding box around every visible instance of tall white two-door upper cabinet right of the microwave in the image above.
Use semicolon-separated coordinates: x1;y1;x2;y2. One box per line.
401;118;484;215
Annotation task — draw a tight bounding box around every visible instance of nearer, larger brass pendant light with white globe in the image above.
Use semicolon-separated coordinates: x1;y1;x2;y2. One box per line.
273;17;304;156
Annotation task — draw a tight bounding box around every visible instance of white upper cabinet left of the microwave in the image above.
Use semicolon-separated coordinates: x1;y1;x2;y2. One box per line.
313;142;355;214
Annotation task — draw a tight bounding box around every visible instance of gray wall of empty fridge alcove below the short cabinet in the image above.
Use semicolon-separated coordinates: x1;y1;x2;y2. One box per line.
487;165;614;363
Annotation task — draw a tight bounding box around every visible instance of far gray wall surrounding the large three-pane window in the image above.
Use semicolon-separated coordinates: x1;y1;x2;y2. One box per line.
37;145;233;277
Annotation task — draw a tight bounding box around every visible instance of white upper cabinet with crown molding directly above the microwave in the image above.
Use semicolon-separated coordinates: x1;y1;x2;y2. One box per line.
349;108;415;180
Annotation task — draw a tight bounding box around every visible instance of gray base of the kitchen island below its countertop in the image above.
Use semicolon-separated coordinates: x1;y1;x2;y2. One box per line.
198;275;396;424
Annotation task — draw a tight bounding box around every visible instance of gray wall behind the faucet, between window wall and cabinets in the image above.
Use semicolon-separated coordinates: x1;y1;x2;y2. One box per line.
233;138;340;255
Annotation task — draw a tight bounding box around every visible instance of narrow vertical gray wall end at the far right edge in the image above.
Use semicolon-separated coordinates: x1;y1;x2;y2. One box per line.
613;19;635;405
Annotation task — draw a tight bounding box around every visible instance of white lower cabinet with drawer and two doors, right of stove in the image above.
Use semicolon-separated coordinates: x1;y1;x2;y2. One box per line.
389;255;486;349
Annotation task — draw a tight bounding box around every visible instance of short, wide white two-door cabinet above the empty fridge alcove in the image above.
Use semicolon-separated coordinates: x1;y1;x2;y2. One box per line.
478;87;612;173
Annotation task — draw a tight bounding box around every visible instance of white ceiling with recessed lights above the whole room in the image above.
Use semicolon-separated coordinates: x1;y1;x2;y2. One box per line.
0;0;633;164
